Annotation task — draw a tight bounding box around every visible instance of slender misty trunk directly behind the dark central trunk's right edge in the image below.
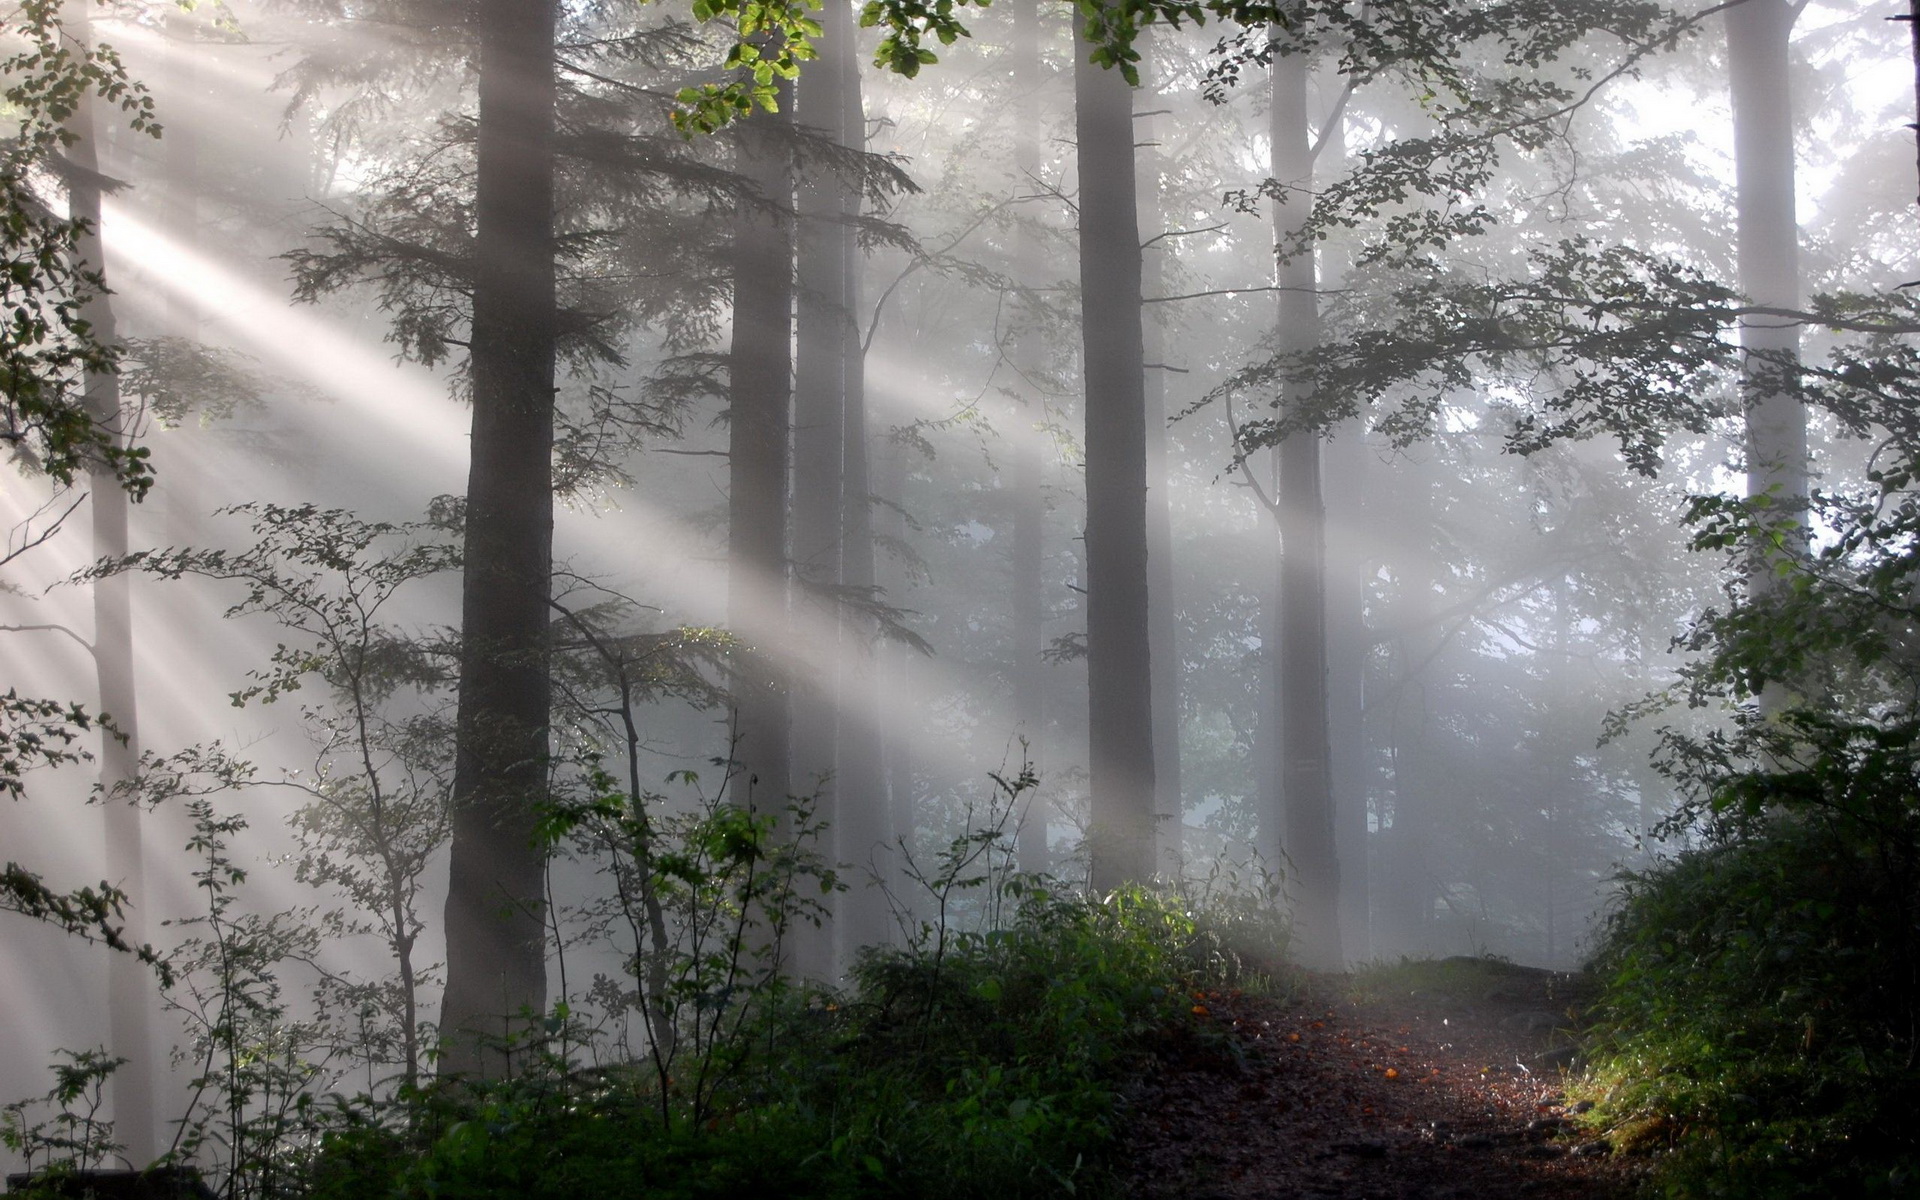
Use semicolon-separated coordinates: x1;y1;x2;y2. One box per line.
1135;79;1185;876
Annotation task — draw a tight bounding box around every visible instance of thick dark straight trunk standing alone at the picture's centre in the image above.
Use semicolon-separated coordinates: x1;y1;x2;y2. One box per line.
1073;29;1154;893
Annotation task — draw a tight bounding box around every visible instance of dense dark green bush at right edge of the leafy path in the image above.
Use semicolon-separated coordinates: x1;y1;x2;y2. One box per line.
1590;716;1920;1198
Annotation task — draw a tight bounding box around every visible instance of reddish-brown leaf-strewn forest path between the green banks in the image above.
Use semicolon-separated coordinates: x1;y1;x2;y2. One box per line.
1121;960;1645;1200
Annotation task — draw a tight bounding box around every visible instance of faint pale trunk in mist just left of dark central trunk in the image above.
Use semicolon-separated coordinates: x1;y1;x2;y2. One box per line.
1006;0;1052;874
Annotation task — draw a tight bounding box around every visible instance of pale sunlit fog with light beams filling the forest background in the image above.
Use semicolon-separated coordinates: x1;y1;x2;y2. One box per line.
0;0;1916;1150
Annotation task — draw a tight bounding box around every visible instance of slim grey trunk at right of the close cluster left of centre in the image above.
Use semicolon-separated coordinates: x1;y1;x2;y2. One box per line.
818;0;895;964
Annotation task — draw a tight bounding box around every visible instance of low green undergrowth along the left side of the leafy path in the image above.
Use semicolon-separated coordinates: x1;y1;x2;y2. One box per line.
305;883;1274;1200
